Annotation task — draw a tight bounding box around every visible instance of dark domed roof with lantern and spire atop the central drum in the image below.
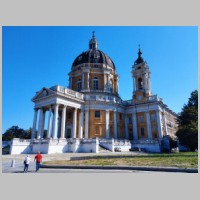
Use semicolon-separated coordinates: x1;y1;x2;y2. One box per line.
72;33;115;70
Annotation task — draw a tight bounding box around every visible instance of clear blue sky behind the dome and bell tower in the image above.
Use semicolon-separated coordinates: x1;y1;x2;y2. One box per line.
2;26;198;133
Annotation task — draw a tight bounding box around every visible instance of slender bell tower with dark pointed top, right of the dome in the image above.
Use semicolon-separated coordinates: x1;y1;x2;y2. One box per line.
131;48;152;102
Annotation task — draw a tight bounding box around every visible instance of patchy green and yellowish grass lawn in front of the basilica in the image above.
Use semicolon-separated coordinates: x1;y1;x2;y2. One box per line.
43;152;198;168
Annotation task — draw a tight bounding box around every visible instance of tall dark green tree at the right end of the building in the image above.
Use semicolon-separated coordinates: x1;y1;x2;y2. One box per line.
176;90;198;151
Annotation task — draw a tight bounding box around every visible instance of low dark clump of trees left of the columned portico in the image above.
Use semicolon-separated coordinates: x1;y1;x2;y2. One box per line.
2;126;31;141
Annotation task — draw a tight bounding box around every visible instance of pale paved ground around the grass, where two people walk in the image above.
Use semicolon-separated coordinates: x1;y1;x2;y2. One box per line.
2;152;198;173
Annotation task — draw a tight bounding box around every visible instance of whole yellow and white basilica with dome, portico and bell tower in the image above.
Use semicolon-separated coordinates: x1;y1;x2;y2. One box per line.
11;32;177;154
